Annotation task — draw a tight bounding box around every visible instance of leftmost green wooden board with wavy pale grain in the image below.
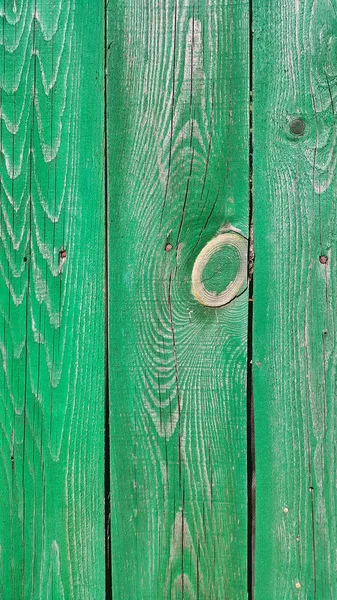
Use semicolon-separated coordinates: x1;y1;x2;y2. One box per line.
0;0;104;600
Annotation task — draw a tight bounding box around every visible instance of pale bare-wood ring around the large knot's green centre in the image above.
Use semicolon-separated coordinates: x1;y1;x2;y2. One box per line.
192;230;248;308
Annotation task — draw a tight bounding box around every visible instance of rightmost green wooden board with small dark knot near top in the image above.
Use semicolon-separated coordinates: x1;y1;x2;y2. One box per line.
253;0;337;600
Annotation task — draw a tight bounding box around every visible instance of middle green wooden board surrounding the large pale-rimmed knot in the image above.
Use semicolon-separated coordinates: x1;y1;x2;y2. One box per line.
107;0;249;600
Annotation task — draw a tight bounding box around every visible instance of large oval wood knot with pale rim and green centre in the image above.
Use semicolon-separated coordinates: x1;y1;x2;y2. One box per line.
192;230;248;308
